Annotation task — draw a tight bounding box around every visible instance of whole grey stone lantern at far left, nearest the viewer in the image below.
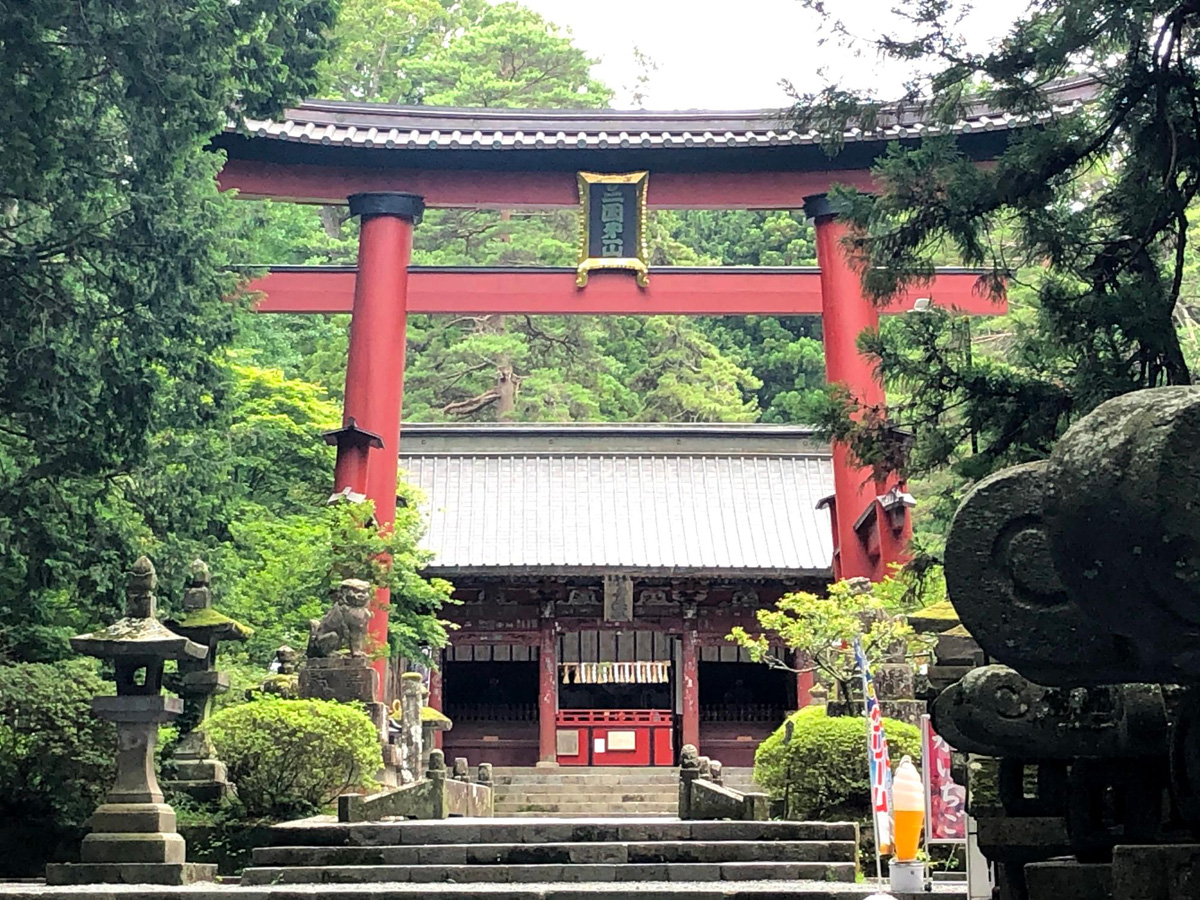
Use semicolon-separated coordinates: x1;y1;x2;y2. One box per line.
46;557;216;884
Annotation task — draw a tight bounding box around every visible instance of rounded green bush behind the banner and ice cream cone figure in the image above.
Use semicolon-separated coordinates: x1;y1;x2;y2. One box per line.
754;707;920;821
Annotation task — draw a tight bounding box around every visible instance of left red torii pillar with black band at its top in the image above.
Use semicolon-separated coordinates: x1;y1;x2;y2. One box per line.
329;192;425;691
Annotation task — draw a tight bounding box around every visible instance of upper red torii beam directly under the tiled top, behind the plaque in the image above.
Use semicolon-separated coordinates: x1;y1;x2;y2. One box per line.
217;160;874;210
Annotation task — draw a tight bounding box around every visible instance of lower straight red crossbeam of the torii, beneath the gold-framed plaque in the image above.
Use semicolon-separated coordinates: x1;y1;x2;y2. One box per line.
246;266;1007;316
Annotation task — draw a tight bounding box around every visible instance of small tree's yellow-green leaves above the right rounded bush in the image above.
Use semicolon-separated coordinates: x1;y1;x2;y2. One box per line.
726;569;946;700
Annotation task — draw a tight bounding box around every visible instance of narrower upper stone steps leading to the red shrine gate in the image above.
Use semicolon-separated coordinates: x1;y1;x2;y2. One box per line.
492;767;754;816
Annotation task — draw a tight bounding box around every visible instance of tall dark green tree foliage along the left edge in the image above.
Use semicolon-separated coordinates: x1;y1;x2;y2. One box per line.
0;0;335;660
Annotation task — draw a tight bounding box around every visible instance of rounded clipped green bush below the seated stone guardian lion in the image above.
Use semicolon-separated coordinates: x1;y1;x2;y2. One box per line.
204;698;380;818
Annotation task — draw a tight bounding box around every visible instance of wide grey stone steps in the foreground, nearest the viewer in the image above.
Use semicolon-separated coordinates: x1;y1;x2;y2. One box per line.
241;818;869;898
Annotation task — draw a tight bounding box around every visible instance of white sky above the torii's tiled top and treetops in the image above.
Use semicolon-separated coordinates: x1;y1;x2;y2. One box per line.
521;0;1024;109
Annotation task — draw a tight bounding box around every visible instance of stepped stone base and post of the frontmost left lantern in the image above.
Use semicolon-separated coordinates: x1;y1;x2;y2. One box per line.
46;695;216;884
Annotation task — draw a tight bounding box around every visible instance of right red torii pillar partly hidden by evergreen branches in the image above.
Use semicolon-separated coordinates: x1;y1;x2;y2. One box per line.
804;193;912;588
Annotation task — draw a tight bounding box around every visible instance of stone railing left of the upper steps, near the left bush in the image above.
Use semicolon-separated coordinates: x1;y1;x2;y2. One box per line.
337;750;493;822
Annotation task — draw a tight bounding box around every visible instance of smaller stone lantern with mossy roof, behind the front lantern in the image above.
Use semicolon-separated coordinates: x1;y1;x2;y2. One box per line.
167;559;253;802
